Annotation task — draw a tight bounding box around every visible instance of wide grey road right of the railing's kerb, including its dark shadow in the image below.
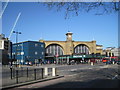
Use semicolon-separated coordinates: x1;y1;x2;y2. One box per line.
1;63;120;90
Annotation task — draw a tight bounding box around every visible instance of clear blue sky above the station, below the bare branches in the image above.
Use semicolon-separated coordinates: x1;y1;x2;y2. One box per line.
2;2;118;48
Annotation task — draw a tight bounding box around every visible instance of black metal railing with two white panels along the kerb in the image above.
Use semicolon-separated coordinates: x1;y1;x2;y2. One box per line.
2;67;56;87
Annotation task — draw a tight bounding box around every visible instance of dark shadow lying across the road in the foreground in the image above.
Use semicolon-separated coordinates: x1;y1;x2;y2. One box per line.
35;79;120;90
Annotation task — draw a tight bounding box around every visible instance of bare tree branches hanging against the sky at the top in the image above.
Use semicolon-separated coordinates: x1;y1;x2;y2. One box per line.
45;0;120;19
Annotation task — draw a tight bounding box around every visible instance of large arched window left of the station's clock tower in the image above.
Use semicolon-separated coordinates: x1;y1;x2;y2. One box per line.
46;44;63;56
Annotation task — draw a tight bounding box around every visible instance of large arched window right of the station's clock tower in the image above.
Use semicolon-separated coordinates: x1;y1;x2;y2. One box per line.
74;44;90;54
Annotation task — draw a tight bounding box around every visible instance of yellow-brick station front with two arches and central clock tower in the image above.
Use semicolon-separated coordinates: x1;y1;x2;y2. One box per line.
39;32;103;56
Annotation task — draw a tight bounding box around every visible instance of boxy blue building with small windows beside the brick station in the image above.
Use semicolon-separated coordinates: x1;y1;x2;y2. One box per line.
12;41;45;64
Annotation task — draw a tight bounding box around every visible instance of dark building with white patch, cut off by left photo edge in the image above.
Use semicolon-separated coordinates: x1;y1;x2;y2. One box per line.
0;34;12;65
